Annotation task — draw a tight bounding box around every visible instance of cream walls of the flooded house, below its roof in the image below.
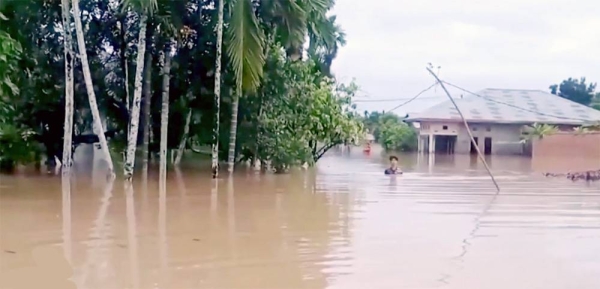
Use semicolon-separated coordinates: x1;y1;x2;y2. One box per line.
420;122;523;155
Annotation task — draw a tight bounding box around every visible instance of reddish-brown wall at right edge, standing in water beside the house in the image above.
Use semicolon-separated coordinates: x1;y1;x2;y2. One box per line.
532;132;600;172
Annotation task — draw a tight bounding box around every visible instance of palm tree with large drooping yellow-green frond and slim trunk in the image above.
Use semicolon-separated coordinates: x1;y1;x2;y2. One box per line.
223;0;335;172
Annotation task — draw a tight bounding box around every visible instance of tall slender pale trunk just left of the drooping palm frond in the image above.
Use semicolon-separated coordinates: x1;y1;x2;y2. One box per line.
212;0;225;179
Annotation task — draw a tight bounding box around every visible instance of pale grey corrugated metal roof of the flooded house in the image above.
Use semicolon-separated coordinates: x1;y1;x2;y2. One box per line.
407;88;600;124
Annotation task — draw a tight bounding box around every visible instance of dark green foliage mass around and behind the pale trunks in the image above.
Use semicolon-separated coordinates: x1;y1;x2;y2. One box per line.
0;0;350;170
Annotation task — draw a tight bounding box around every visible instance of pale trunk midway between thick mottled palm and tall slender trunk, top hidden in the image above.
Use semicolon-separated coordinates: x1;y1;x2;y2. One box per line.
159;46;171;180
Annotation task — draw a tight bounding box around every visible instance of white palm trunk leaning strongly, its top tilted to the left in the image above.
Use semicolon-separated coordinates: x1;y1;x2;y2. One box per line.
73;0;114;177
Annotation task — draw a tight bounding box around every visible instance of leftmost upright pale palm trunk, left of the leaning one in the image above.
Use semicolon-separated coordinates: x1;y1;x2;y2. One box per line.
61;0;74;175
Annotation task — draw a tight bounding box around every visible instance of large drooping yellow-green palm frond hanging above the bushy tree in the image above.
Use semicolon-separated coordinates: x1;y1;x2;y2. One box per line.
225;0;265;92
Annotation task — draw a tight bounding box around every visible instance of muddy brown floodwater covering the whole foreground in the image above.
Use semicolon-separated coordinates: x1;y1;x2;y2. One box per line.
0;152;600;289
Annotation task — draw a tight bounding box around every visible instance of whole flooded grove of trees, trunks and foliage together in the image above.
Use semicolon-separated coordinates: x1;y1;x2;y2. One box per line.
0;0;360;173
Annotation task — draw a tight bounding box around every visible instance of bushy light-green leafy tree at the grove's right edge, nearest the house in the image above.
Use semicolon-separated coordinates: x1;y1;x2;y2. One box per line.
246;47;363;171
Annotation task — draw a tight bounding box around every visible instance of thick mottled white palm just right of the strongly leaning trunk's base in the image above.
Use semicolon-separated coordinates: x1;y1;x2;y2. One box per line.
123;0;158;180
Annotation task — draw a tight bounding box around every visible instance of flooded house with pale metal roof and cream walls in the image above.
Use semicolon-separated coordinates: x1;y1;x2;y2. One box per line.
406;89;600;155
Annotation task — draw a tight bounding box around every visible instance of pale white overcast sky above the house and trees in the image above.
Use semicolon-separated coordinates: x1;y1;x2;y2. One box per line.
333;0;600;114
